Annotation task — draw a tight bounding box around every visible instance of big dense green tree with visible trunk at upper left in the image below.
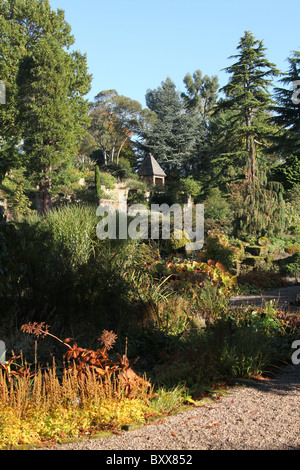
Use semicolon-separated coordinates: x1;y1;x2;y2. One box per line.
0;0;91;214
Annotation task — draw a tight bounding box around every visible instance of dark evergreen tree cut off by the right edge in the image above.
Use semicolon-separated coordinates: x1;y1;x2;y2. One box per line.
273;51;300;189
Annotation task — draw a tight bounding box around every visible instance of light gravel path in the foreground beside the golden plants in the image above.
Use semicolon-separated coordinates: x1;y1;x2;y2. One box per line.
43;365;300;451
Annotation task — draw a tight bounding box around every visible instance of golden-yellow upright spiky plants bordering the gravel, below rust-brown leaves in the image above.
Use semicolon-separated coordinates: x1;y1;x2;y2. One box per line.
0;366;153;449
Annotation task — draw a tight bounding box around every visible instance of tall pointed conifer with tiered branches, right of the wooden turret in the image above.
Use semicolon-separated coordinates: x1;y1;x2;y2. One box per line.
218;31;279;181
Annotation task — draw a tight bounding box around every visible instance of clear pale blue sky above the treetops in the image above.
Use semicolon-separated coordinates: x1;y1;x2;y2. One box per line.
50;0;300;106
